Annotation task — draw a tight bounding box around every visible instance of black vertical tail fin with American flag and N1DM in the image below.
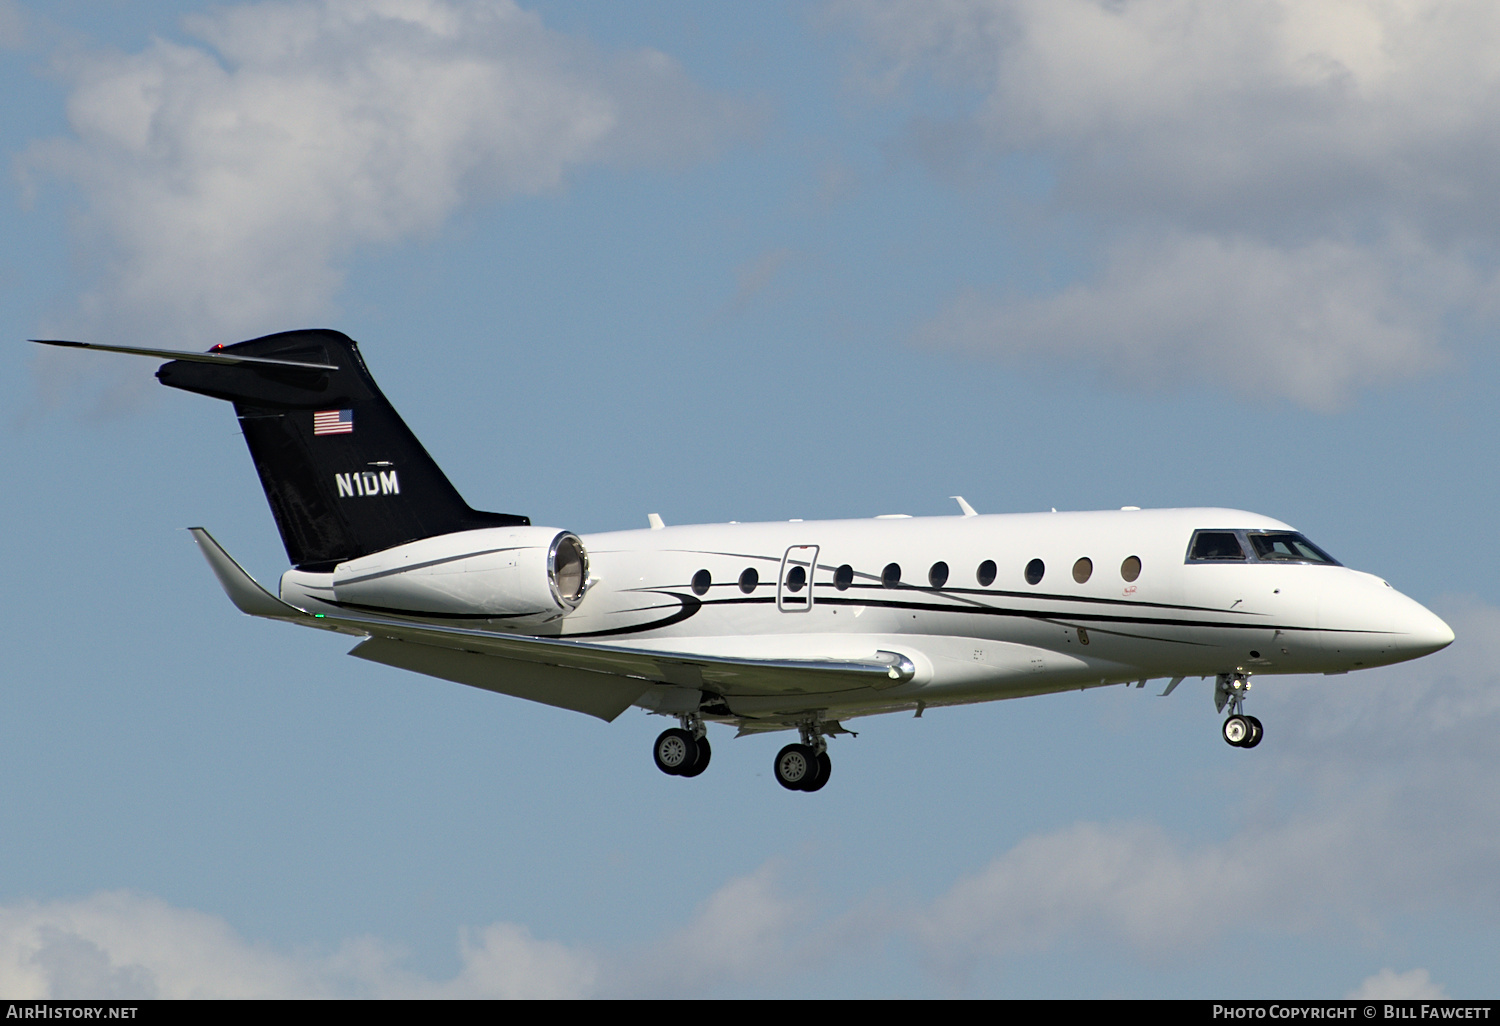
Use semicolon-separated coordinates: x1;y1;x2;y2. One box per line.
156;329;531;572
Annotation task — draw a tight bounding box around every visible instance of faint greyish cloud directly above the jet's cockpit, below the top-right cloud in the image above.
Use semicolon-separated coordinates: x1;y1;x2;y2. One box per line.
923;234;1445;410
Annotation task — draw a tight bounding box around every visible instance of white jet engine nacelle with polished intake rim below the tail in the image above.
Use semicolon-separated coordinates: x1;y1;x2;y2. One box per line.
333;527;588;620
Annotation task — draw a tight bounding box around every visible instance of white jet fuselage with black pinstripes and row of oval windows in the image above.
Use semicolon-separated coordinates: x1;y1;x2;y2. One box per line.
282;509;1452;719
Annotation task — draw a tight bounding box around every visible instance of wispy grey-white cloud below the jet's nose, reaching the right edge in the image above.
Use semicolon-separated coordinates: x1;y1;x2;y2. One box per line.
909;804;1496;986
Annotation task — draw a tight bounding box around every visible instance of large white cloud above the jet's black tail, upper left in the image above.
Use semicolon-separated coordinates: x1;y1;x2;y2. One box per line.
24;0;737;345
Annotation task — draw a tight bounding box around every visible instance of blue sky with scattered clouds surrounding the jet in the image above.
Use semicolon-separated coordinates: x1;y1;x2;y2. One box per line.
0;0;1500;998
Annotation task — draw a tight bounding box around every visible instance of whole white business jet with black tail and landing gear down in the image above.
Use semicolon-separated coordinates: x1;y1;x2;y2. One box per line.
38;330;1454;791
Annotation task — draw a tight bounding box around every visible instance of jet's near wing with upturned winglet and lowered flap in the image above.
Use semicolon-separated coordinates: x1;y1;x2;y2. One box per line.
189;528;917;720
